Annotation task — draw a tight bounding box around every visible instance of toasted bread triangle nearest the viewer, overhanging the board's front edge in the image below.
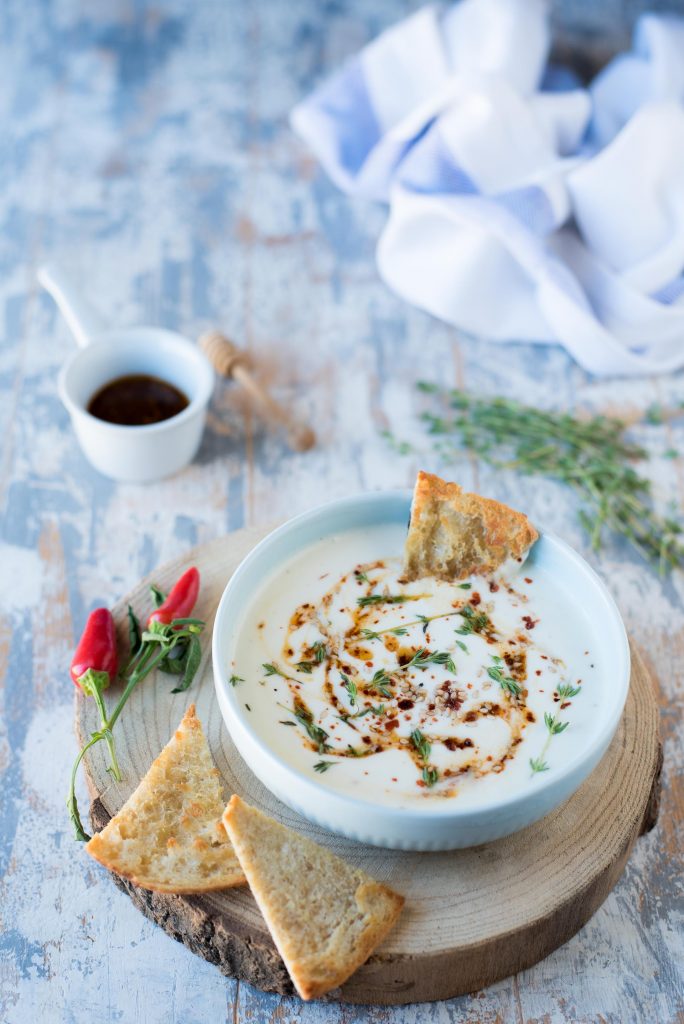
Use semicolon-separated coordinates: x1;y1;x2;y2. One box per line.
223;797;403;999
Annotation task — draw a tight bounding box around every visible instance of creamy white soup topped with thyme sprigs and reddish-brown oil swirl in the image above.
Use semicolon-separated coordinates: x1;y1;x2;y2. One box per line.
228;525;601;806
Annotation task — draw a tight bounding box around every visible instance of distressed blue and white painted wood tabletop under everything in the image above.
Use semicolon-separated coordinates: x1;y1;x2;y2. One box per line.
0;0;684;1024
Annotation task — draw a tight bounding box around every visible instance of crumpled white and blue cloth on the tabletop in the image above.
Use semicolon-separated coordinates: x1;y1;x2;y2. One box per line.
292;0;684;375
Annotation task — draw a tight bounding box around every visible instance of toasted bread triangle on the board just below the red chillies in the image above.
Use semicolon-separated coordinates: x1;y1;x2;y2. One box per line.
86;705;246;893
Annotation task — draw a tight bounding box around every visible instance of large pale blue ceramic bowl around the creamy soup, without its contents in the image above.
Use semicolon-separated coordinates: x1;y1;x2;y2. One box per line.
213;492;630;850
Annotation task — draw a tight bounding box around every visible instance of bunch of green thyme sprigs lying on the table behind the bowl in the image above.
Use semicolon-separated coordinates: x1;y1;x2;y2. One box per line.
401;382;684;573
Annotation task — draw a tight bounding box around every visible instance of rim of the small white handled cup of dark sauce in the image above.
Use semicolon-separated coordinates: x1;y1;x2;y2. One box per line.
57;327;214;434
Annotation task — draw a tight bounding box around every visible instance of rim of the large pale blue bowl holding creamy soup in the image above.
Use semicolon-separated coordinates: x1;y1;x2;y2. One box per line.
212;489;631;821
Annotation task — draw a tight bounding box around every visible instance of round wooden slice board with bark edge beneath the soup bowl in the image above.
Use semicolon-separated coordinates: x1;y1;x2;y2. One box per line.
76;528;661;1004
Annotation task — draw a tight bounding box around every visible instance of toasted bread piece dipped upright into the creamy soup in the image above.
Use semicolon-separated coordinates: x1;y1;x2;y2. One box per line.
403;472;539;580
